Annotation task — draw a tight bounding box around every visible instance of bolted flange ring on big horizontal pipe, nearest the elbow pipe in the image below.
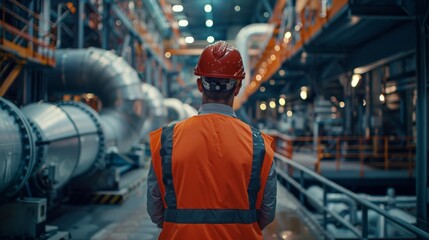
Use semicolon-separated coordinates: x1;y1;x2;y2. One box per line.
56;101;106;169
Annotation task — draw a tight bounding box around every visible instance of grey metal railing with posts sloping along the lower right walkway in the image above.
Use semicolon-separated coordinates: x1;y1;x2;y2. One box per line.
275;153;429;239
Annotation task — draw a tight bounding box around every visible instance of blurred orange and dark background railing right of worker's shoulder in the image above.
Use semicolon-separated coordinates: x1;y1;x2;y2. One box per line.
271;133;416;177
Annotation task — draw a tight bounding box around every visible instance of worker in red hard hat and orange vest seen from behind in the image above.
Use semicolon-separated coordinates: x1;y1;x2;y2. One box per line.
147;41;277;240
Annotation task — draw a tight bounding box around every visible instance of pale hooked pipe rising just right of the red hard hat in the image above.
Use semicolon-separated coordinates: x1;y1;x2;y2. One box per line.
235;23;274;103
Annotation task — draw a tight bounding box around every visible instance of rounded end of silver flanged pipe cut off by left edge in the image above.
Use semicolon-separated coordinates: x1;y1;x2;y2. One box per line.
0;97;36;202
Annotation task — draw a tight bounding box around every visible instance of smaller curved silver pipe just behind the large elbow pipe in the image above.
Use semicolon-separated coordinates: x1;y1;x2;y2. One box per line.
140;83;168;142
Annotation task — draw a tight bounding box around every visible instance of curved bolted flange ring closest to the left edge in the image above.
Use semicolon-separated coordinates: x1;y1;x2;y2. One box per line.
0;98;36;200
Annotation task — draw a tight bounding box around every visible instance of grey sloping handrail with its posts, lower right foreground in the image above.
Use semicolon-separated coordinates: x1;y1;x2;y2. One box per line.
274;153;429;239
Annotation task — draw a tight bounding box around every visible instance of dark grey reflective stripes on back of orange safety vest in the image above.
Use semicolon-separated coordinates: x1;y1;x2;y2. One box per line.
160;124;265;224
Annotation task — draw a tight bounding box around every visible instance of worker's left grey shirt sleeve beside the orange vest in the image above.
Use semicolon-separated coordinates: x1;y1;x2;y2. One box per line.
147;163;164;228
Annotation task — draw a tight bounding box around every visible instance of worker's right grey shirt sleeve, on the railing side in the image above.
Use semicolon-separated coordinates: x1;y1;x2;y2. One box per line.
258;161;277;230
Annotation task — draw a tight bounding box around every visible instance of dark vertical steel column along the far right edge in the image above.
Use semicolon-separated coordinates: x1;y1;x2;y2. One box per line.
416;0;429;230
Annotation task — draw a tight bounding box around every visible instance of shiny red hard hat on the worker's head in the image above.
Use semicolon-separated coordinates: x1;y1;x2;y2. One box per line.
194;41;245;80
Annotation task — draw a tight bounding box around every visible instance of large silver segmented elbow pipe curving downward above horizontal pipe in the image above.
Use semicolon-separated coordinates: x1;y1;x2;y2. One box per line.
47;48;145;152
